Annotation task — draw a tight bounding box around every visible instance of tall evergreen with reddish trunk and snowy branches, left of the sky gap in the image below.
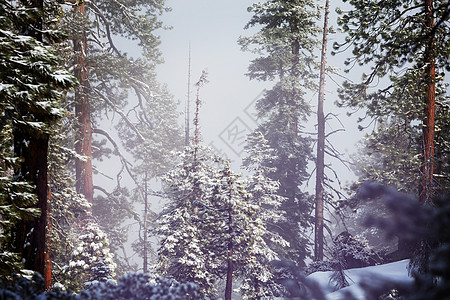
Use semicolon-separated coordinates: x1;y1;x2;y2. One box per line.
62;0;169;202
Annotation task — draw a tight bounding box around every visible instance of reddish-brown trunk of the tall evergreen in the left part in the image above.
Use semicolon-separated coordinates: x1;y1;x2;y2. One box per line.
73;3;94;203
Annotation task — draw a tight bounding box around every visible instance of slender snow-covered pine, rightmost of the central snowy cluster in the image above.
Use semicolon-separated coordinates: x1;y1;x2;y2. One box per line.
240;131;289;299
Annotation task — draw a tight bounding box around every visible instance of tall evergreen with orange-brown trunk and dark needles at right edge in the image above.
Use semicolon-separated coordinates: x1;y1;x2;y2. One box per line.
334;0;450;203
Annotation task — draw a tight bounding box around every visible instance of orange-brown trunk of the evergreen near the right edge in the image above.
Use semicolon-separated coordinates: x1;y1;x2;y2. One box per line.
420;0;436;203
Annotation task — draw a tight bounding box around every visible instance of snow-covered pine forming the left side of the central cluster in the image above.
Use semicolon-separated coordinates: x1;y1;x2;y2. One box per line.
155;145;218;296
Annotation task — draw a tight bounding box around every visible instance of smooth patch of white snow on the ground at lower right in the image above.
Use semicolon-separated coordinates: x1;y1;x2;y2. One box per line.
308;259;413;300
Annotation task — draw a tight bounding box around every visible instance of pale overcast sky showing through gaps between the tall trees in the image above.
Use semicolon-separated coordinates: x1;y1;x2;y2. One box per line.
158;0;362;191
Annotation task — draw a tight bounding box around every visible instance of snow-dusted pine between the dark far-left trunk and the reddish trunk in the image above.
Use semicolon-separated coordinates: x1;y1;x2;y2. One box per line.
49;122;121;291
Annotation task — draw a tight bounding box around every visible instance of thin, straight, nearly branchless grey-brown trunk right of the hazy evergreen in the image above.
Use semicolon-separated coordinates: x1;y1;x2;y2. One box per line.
314;0;329;261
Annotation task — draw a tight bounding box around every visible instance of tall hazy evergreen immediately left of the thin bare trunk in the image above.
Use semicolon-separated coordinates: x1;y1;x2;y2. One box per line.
239;0;320;265
